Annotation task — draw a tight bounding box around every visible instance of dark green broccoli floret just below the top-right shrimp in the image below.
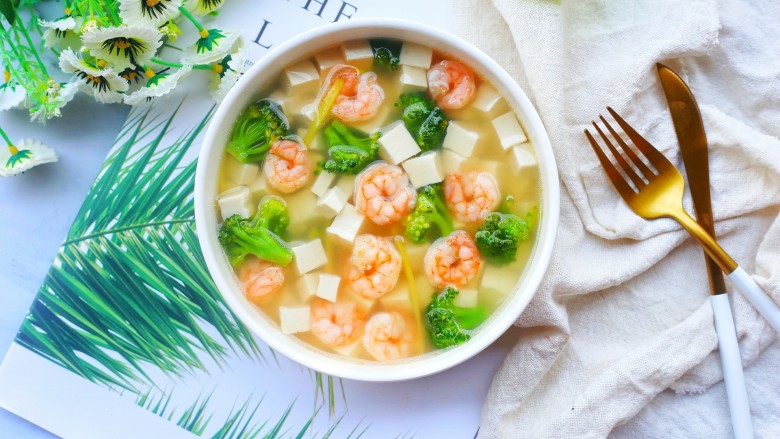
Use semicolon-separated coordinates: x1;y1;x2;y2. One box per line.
395;92;450;151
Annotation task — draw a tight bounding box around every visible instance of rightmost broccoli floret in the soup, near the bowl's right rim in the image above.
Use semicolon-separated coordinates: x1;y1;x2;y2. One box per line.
474;212;531;265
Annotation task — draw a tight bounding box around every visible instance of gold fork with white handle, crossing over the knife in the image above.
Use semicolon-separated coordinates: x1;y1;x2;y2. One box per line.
585;107;780;332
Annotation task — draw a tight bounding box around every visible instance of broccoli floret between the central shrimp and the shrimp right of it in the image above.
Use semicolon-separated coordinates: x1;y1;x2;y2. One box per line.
404;184;453;243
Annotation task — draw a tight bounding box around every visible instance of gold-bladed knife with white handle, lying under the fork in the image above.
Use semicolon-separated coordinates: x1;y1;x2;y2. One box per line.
656;63;753;439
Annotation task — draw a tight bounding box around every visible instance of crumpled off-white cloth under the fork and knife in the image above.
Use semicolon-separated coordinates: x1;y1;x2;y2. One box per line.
453;0;780;438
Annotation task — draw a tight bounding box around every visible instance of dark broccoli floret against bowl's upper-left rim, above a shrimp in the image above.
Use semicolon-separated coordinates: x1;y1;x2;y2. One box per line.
227;99;290;163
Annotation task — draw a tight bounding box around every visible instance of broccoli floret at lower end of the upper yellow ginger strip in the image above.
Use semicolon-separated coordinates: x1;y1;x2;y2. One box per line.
322;121;380;174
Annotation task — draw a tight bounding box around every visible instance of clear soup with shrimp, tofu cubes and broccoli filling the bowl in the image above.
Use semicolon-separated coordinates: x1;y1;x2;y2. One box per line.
216;40;541;361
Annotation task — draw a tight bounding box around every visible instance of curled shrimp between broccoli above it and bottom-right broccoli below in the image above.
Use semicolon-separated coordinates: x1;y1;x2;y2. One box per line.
424;230;481;288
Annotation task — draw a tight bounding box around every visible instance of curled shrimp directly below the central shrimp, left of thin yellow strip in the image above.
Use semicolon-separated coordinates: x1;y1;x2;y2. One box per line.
347;235;401;299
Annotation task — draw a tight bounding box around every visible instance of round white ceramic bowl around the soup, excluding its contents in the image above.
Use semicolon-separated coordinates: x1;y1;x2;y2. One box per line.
195;19;560;381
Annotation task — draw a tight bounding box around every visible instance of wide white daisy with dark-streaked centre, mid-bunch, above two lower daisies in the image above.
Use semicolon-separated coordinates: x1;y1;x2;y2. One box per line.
81;25;162;68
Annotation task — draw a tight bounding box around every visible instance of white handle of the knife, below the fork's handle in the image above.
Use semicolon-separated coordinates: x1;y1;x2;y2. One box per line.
710;294;753;439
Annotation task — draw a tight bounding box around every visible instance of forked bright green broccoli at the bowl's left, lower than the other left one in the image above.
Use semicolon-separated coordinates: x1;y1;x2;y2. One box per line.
218;197;293;267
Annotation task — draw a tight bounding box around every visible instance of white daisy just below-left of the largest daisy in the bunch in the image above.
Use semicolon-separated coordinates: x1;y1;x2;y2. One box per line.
60;50;130;104
